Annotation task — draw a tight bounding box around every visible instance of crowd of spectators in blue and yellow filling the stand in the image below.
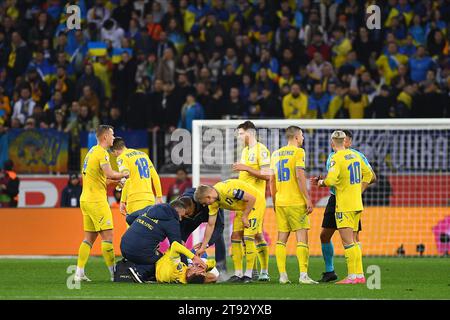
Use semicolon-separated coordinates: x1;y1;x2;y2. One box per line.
0;0;450;170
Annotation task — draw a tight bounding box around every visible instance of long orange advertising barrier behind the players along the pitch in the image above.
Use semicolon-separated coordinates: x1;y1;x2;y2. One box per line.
0;207;450;256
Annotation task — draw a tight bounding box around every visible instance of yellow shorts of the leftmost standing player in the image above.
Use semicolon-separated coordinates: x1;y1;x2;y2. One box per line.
80;201;114;232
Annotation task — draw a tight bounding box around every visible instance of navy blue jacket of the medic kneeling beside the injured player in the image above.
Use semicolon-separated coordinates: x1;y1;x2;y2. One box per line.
120;203;181;256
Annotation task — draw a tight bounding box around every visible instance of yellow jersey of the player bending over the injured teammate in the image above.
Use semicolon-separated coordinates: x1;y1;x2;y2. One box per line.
209;179;265;216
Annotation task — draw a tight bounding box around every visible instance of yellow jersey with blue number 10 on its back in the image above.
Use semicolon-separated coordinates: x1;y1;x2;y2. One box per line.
324;149;373;212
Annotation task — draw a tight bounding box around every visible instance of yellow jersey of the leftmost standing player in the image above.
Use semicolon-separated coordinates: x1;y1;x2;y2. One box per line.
80;145;109;202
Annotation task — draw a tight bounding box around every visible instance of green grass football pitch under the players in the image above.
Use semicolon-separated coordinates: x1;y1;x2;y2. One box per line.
0;257;450;300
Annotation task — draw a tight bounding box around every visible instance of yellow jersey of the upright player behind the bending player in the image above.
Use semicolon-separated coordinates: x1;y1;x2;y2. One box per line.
239;142;270;195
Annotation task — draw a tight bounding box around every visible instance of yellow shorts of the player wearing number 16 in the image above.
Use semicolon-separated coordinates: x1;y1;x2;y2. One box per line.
275;206;311;232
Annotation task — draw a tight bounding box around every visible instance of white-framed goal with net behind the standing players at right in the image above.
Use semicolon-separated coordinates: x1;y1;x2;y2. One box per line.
192;119;450;256
